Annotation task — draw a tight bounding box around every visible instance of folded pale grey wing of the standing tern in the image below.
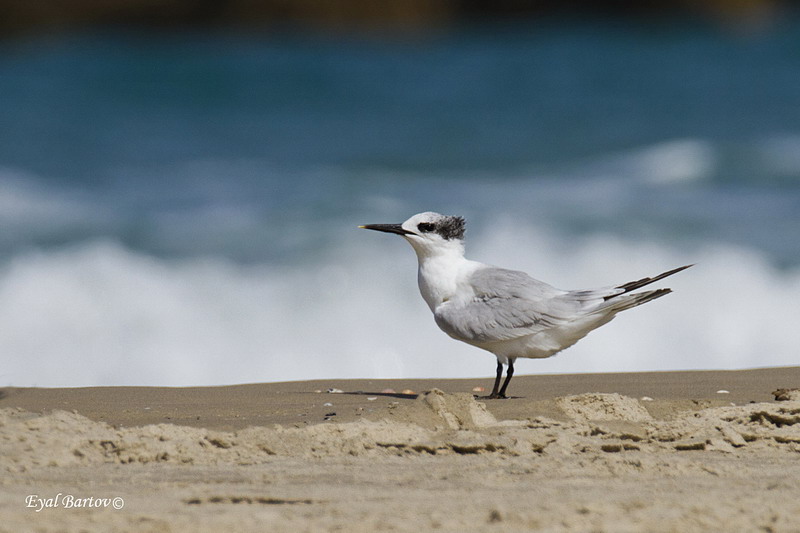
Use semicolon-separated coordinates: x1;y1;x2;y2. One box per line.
434;267;573;344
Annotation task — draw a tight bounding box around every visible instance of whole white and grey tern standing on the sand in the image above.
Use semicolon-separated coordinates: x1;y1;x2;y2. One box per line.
359;212;692;399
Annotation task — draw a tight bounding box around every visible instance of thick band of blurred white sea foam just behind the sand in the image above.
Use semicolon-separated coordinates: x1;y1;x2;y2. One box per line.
0;224;800;386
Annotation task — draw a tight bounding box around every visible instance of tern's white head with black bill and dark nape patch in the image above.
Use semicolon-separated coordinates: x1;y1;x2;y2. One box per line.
359;211;465;258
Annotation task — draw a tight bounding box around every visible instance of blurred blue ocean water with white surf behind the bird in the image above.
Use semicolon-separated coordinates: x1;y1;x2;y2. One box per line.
0;21;800;386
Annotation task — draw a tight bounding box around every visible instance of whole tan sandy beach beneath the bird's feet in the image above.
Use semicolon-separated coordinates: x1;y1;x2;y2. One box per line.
0;367;800;532
